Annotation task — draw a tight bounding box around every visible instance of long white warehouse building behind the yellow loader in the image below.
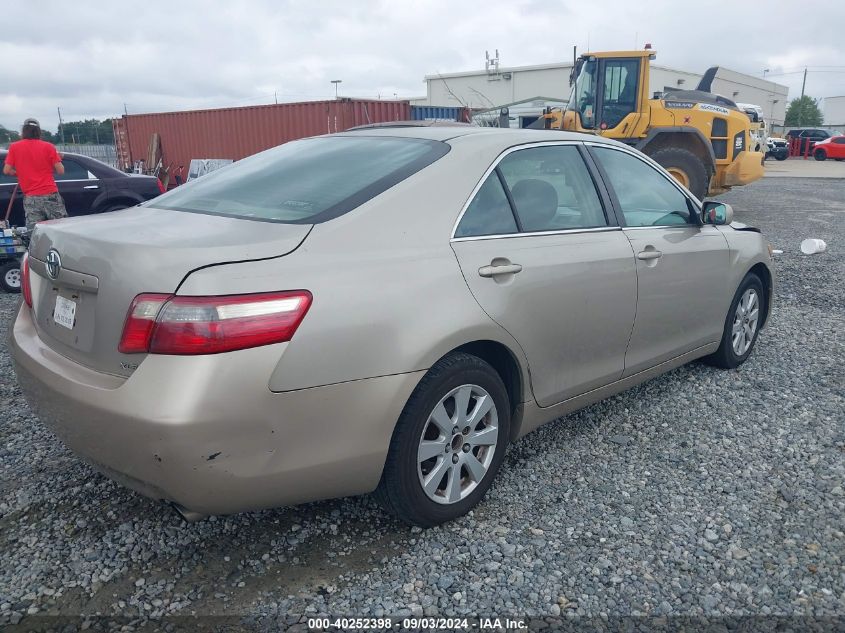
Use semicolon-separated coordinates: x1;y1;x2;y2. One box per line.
411;62;789;124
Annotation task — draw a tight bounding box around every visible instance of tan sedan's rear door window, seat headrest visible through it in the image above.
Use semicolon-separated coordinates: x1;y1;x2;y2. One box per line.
499;145;607;232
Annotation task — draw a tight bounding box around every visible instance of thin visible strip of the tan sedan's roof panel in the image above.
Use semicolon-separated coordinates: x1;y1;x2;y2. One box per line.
337;125;619;146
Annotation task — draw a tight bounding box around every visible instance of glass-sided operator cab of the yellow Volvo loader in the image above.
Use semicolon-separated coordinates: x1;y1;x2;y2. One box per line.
566;51;649;138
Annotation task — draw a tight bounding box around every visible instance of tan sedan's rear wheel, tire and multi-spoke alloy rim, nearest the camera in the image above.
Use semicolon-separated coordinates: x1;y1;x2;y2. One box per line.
376;353;510;527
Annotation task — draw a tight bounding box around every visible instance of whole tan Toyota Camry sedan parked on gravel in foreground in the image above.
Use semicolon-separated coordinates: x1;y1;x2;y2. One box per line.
11;127;773;526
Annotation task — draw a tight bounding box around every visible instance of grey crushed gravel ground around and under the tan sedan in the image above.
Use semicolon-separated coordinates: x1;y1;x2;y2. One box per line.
0;179;845;627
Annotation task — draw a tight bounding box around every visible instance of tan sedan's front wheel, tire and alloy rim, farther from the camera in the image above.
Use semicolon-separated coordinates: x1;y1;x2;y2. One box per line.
704;273;767;369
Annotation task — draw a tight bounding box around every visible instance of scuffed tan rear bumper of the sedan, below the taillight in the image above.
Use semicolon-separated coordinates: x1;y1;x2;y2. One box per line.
10;306;424;514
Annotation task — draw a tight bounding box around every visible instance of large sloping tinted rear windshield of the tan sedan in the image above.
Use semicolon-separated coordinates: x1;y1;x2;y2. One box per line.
147;135;449;224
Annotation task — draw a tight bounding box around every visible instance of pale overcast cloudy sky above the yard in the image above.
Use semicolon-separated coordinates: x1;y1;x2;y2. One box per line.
0;0;845;130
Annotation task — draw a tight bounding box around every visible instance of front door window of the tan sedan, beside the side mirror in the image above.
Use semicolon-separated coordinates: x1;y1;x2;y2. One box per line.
591;147;695;226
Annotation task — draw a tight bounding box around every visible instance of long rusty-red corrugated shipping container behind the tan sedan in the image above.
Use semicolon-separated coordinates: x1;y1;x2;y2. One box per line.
113;98;411;178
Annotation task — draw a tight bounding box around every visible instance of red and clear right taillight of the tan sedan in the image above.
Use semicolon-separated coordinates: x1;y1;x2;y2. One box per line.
118;290;311;355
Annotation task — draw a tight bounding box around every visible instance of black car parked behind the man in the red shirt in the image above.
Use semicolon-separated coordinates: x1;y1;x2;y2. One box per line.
0;150;164;226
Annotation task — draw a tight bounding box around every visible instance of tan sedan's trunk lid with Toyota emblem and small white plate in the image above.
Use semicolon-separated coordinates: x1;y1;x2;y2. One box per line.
30;207;312;376
